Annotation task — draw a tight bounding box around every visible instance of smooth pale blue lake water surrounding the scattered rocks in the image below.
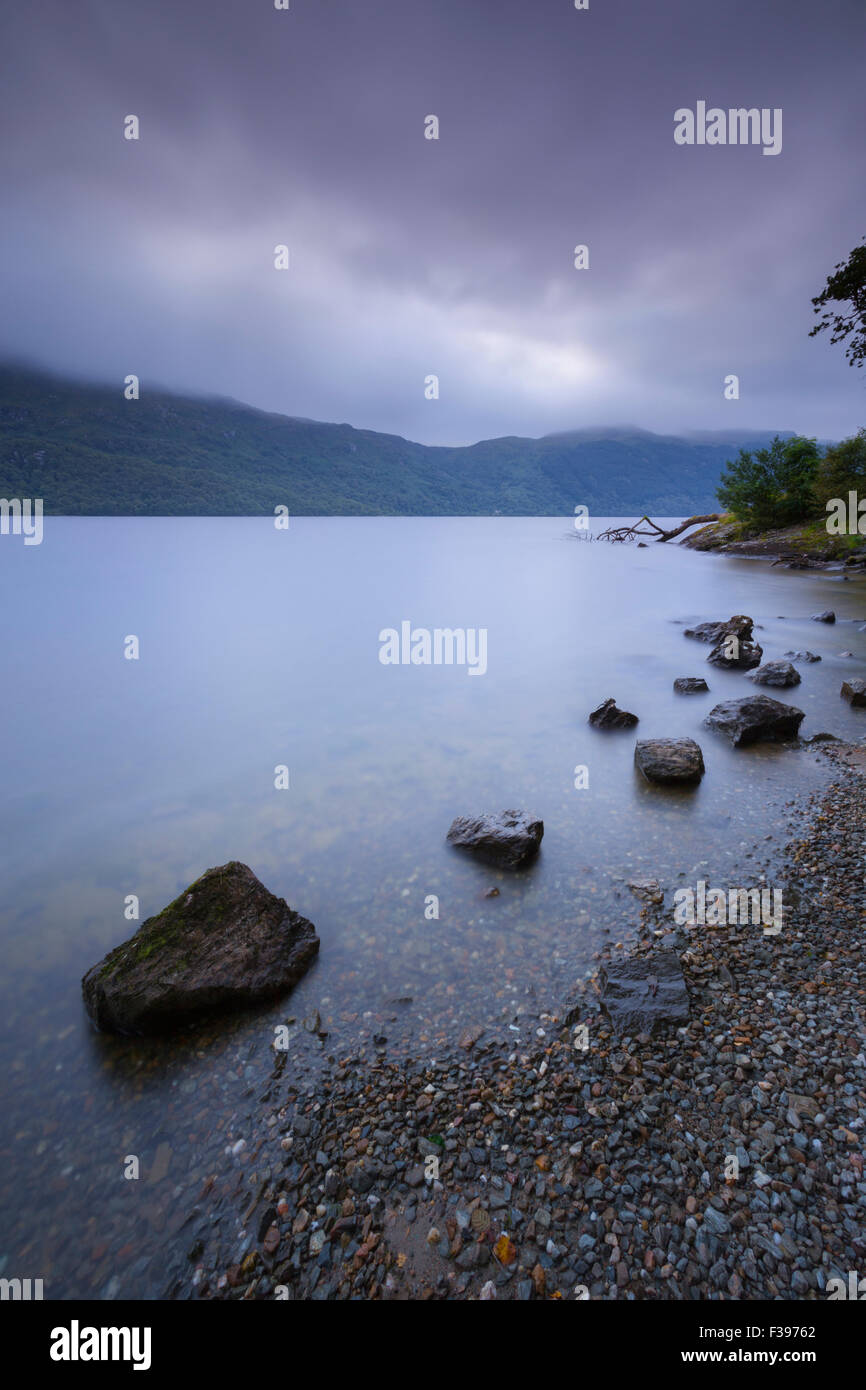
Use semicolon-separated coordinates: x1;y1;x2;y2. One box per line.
0;518;866;1298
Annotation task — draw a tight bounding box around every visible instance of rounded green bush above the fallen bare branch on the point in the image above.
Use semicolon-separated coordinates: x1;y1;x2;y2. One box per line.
716;435;822;530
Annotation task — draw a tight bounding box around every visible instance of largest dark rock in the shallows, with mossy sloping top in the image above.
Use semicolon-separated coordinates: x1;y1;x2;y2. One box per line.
82;860;318;1033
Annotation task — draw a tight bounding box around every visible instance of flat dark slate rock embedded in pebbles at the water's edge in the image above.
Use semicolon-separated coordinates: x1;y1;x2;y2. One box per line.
601;951;689;1037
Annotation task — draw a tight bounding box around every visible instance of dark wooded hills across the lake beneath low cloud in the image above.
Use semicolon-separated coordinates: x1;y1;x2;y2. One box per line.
0;366;800;516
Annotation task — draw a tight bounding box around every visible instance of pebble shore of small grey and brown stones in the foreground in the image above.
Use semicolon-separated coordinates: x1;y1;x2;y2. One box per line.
191;744;866;1300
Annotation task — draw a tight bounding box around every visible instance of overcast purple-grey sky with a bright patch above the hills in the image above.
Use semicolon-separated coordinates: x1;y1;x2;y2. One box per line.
0;0;866;443
